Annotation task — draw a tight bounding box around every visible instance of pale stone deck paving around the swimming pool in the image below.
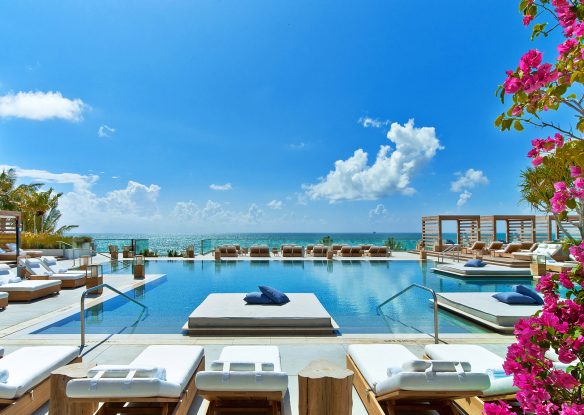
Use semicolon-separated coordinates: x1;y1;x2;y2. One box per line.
0;252;513;415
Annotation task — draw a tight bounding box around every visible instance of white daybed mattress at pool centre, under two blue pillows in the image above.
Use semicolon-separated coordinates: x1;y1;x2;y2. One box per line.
187;293;336;331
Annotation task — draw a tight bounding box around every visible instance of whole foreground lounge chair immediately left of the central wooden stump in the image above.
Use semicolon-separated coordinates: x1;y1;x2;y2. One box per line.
196;346;288;415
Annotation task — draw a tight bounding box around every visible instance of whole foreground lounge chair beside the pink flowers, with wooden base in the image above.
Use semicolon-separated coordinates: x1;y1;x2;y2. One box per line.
424;344;517;415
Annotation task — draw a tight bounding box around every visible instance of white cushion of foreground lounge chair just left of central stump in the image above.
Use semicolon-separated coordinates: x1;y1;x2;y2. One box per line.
196;346;288;396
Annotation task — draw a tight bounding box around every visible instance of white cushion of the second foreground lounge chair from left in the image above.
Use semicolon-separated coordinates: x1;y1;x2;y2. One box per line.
66;346;203;398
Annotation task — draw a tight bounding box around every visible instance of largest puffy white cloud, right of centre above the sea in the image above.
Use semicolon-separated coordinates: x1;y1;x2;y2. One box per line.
303;119;443;202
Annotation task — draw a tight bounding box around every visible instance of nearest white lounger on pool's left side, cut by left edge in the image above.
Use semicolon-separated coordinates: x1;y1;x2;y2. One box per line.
0;264;61;301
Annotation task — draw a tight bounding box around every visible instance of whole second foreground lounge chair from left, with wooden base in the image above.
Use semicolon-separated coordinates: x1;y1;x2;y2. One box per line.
66;345;205;415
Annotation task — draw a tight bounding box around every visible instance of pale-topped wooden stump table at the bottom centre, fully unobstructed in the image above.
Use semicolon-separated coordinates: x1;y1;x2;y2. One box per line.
298;360;353;415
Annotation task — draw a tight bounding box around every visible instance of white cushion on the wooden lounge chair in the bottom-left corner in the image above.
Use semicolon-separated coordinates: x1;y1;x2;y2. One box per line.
0;346;79;399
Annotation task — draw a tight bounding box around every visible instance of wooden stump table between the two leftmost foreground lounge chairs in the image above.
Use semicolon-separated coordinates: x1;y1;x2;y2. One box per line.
49;363;99;415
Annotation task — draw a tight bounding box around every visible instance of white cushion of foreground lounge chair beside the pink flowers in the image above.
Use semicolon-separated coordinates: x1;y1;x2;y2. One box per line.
424;344;517;396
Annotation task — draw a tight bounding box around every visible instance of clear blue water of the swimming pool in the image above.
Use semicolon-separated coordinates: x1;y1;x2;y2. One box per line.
35;261;531;334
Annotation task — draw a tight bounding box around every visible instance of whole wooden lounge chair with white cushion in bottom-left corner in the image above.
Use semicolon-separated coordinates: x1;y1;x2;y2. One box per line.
0;346;81;415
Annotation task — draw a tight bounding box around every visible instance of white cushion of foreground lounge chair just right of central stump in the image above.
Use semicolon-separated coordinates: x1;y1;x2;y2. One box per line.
348;344;490;396
